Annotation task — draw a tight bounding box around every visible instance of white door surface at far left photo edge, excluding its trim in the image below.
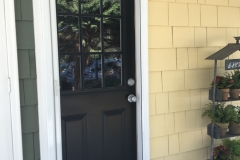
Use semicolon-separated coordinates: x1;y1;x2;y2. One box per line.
0;0;13;160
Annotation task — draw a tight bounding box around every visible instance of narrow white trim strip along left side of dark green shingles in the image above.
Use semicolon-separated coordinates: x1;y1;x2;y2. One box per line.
3;0;23;160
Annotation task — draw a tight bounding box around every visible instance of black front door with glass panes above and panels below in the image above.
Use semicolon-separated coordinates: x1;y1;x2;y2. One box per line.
57;0;136;160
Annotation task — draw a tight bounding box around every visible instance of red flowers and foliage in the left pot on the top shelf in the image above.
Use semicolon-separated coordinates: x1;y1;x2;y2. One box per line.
211;75;234;89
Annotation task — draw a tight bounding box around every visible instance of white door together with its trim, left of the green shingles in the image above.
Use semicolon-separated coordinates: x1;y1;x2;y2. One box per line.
0;0;23;160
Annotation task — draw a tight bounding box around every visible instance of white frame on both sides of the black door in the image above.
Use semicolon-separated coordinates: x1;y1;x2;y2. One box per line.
33;0;150;160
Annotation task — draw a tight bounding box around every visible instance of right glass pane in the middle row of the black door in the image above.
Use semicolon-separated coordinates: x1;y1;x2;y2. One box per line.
103;18;121;52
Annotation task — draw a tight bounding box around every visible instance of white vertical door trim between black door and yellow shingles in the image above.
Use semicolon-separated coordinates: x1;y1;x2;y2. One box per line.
135;0;150;160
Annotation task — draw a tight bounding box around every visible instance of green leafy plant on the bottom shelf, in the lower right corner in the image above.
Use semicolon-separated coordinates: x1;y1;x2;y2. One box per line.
222;139;240;160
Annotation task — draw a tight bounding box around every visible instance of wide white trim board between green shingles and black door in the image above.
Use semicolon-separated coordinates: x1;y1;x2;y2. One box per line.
33;0;56;160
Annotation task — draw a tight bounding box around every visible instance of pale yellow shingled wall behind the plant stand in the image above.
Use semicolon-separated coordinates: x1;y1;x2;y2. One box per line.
148;0;240;160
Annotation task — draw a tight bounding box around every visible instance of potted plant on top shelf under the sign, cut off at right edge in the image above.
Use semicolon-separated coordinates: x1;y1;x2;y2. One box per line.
229;70;240;99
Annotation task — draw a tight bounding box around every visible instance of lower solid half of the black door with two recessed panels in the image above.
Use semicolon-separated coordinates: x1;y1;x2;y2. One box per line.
61;91;136;160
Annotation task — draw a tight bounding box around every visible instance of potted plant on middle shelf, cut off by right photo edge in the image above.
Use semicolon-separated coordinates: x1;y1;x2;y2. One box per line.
228;106;240;134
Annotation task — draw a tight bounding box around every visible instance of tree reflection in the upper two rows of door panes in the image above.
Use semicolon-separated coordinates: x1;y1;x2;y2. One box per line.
57;0;120;52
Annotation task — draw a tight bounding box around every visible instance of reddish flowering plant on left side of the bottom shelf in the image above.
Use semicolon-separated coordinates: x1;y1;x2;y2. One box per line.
213;145;232;160
